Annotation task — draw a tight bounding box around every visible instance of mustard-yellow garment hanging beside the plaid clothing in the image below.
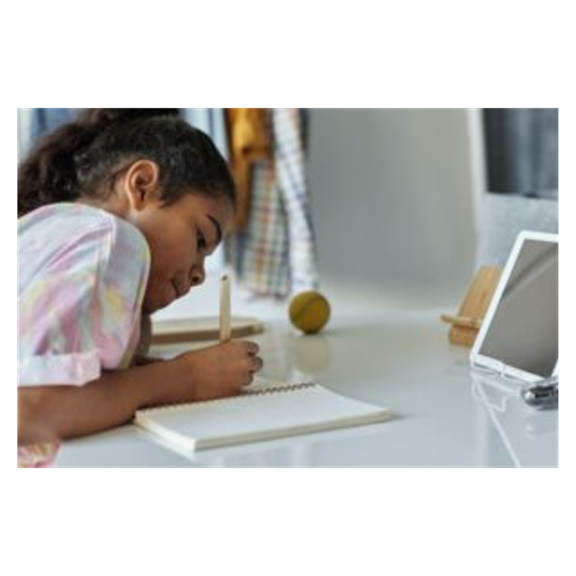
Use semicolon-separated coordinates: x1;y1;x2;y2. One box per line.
226;107;272;232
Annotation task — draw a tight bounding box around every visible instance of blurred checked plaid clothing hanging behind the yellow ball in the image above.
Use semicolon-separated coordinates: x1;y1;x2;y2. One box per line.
230;107;319;297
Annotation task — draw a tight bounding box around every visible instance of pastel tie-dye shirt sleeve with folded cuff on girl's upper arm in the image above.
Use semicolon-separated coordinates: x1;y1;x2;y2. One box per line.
17;218;150;386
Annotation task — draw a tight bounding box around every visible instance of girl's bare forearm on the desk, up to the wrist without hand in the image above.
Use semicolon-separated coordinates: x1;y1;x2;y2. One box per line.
17;361;187;445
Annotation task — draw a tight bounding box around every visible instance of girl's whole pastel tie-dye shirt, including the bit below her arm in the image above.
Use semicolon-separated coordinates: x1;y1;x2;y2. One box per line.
16;204;150;468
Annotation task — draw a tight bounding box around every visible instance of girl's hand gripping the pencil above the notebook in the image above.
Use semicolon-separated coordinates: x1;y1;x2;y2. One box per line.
170;341;263;401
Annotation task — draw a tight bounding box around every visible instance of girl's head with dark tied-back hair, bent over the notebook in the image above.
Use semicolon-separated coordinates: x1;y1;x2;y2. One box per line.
17;107;235;312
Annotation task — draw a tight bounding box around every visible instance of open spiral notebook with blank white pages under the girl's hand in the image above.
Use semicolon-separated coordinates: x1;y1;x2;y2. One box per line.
135;379;392;454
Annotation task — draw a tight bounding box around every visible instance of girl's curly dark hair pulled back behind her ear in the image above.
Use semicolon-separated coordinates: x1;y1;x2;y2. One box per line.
16;107;235;216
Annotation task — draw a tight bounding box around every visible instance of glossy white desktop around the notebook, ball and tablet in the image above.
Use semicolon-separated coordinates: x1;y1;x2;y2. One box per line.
58;311;560;468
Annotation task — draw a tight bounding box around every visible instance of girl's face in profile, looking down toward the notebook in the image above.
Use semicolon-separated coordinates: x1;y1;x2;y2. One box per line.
117;162;233;314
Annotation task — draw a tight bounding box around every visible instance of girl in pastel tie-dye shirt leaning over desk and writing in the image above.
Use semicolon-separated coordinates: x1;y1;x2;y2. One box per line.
16;107;262;467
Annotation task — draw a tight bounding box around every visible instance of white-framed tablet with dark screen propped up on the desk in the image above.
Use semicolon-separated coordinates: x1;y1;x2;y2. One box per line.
470;232;560;382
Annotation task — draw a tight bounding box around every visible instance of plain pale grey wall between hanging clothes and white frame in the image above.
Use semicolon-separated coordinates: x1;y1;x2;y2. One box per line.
310;107;483;304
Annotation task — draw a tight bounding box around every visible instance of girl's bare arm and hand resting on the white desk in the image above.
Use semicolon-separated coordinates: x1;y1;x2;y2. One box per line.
17;342;262;446
